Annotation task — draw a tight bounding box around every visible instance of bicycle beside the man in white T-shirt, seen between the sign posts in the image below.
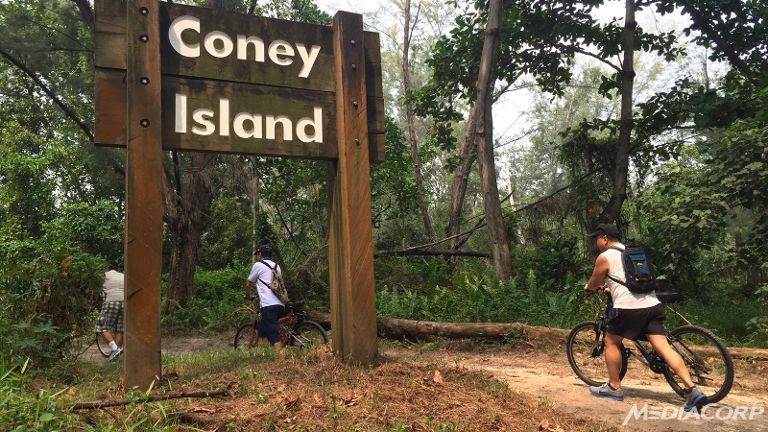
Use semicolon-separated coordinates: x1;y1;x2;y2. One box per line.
233;302;328;349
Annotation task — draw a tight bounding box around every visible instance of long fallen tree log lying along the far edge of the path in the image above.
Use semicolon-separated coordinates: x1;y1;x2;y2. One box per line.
309;311;768;362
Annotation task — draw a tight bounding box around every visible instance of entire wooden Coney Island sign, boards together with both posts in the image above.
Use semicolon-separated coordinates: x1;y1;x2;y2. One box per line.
94;0;384;389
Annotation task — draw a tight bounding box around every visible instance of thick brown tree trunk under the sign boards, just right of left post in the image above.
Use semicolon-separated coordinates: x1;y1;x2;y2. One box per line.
164;152;216;315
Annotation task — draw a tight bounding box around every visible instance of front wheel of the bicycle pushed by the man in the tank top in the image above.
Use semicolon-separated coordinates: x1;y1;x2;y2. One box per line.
566;321;627;386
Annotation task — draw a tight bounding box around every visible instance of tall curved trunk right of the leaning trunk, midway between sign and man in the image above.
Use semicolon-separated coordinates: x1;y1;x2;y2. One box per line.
473;0;512;279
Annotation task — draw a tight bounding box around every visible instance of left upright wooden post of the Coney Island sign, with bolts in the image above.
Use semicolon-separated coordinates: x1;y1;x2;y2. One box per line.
125;0;163;390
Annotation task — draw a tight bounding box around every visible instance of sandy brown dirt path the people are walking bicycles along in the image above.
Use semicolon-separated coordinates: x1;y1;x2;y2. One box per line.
84;333;768;432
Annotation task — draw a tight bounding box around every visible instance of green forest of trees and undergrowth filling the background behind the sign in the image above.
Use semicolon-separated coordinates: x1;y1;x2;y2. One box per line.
0;0;768;372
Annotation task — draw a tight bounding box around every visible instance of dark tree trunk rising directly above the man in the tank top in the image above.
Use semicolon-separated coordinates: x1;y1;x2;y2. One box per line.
598;0;637;228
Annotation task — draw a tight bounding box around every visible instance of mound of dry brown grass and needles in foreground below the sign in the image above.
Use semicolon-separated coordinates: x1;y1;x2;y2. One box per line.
67;350;602;431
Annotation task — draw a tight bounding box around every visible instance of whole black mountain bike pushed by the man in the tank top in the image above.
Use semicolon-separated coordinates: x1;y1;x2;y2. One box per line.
566;292;734;403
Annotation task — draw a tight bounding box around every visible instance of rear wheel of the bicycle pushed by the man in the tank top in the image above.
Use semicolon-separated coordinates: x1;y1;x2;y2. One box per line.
664;325;733;403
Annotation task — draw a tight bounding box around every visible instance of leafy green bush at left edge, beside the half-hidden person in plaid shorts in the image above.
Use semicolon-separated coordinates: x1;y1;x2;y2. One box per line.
0;237;104;367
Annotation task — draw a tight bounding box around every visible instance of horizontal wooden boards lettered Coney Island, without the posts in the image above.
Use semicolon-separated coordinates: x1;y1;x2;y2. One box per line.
94;0;384;162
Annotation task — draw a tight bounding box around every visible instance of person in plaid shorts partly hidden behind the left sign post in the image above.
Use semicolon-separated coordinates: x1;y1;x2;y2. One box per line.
96;265;125;361
